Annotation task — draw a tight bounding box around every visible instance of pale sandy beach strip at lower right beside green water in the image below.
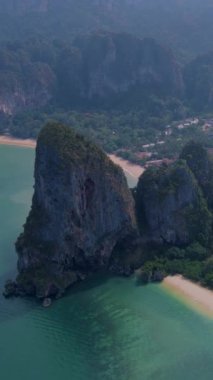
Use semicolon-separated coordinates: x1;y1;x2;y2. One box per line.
162;275;213;318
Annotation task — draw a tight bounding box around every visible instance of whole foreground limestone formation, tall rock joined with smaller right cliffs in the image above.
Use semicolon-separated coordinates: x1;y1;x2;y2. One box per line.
4;129;213;299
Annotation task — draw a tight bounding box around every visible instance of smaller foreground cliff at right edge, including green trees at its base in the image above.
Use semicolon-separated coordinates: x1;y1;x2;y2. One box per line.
134;147;213;288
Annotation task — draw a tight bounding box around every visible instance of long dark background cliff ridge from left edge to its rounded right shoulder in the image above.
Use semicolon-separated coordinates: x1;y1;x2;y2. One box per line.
0;32;183;114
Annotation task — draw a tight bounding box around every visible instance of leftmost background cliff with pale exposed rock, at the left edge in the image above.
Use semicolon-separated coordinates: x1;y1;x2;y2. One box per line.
0;58;55;114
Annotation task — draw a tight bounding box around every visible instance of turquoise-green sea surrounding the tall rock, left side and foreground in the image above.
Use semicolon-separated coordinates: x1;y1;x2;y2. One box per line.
0;146;213;380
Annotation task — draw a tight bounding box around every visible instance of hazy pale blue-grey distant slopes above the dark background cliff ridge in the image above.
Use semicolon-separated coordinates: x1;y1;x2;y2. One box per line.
0;0;213;59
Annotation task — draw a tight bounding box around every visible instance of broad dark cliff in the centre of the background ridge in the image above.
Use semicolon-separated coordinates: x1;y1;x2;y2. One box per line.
74;33;183;99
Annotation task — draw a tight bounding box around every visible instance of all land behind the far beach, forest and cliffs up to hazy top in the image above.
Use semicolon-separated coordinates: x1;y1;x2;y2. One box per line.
0;0;213;161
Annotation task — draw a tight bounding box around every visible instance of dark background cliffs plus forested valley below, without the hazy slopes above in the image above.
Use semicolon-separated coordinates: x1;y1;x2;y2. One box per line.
0;31;213;158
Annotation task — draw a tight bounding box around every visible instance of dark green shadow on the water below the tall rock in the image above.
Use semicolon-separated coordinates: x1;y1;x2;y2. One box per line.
44;273;125;380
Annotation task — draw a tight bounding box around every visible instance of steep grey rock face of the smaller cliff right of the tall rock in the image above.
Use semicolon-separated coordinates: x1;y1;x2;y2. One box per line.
136;161;211;246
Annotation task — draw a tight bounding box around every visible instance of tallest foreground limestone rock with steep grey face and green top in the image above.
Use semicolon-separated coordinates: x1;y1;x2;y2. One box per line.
16;124;135;297
